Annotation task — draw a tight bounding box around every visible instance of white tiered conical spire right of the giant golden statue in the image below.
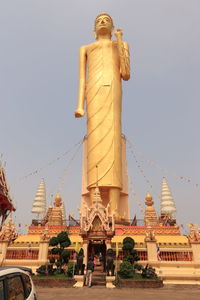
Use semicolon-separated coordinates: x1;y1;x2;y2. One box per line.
160;177;176;216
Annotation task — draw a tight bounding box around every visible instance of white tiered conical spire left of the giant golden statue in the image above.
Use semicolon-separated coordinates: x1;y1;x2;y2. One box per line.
32;179;46;216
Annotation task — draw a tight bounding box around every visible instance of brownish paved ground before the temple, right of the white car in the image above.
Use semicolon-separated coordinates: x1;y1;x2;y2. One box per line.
37;286;200;300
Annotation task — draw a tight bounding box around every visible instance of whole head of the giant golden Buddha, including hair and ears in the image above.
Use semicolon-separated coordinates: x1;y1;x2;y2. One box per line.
94;13;114;39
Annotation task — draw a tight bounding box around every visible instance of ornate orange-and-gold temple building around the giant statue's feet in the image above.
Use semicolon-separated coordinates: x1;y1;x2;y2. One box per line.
0;172;200;284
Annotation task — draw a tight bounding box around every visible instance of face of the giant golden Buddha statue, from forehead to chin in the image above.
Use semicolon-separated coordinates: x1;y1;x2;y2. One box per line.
95;15;113;36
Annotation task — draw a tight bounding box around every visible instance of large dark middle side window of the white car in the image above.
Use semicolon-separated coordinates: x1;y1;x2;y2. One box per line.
7;275;25;300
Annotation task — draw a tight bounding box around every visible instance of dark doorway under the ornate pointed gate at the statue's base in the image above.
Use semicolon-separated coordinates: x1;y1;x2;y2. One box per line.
88;240;106;272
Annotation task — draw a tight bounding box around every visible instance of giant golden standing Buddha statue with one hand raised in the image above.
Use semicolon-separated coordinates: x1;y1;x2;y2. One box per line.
75;13;130;214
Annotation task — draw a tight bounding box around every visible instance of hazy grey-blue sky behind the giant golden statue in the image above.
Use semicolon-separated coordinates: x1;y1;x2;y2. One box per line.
0;0;200;232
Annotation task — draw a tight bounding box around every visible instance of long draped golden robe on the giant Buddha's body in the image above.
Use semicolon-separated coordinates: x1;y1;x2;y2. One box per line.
85;40;122;189
